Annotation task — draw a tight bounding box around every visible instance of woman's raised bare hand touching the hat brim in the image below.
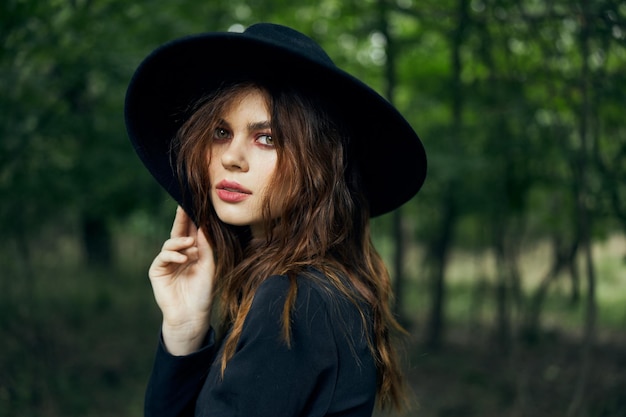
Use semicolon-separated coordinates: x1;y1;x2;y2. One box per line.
148;207;215;355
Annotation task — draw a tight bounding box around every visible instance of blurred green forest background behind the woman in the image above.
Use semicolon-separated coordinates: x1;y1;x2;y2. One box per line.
0;0;626;417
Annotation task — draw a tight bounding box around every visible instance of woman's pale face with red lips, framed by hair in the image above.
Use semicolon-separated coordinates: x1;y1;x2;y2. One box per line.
209;89;277;237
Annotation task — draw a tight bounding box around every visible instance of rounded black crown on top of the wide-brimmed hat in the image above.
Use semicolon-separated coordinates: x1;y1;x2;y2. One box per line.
243;23;336;67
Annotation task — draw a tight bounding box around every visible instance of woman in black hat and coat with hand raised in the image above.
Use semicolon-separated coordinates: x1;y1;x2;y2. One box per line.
125;23;426;416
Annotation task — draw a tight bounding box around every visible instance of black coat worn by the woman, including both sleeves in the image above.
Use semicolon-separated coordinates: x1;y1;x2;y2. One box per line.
145;276;376;417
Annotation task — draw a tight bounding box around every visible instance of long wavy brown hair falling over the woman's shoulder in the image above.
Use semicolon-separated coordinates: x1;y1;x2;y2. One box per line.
173;82;405;409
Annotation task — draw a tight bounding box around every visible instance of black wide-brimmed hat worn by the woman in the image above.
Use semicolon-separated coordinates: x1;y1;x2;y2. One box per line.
125;23;426;216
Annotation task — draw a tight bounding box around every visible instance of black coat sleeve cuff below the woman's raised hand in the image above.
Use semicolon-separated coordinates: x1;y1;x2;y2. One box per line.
144;330;216;417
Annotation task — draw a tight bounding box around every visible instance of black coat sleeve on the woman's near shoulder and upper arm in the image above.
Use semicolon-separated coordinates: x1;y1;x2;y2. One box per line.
196;276;338;417
